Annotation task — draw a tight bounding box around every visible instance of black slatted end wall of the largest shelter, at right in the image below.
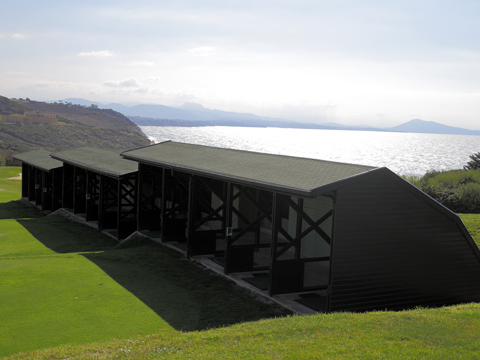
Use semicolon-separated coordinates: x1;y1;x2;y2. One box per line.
330;175;480;311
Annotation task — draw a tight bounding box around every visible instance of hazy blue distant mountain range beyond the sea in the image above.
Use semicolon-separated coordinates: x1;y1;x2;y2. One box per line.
58;98;480;135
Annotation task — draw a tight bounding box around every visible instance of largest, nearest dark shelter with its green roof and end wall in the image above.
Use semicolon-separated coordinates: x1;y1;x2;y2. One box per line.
122;142;480;312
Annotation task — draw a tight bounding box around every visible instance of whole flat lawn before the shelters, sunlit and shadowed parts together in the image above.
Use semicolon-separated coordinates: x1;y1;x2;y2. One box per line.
0;168;288;357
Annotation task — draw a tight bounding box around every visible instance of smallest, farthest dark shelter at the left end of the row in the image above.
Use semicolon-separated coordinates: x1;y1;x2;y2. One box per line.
13;150;63;212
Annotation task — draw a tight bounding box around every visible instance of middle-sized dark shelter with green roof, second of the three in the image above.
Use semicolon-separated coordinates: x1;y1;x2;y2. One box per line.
51;147;138;240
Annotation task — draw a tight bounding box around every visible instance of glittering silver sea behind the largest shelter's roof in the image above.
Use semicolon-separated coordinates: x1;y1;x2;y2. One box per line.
140;126;480;175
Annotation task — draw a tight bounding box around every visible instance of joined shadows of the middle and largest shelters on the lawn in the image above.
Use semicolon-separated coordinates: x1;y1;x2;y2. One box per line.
17;208;290;331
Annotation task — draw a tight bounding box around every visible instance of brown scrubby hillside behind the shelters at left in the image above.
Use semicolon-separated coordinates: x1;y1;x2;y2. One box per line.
0;96;150;165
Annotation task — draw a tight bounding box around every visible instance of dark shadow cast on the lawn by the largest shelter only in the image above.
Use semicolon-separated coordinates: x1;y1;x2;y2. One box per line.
84;237;290;331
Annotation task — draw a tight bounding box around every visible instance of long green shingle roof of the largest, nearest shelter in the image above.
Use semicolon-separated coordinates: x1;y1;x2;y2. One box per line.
121;141;377;196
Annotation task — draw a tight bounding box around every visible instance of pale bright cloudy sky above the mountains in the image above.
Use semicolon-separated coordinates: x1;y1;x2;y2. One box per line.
0;0;480;130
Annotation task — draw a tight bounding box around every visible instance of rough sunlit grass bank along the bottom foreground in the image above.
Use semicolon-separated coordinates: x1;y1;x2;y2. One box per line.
9;304;480;360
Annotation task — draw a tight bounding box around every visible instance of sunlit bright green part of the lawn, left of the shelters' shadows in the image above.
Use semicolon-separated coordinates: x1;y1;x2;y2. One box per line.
0;168;174;357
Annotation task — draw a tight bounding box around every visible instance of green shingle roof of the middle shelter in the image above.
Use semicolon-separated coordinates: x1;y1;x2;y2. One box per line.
51;147;138;178
